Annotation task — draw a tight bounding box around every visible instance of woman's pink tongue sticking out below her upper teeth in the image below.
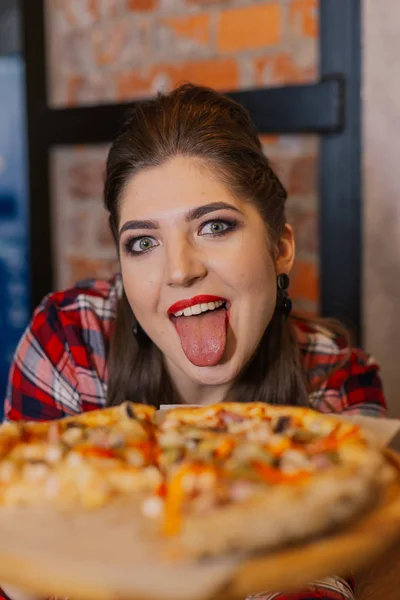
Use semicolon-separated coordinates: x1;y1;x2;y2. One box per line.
175;308;228;367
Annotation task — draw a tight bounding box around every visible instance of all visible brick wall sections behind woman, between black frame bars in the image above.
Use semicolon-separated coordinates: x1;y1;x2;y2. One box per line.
47;0;319;312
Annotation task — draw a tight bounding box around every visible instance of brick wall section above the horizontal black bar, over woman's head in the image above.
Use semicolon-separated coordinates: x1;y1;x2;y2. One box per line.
47;0;318;106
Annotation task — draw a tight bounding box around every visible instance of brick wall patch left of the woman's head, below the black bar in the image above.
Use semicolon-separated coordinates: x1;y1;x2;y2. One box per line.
51;146;118;289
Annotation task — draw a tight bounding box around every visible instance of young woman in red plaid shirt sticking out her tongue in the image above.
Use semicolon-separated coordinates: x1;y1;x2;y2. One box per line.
1;85;385;599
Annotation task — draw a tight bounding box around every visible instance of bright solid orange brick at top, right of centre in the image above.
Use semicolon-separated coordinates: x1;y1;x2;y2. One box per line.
217;2;282;52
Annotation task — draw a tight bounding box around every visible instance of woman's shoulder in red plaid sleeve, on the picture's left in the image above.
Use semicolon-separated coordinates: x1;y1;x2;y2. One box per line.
5;276;122;420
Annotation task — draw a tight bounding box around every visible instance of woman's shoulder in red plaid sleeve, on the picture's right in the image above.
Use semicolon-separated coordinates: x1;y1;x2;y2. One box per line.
293;319;386;416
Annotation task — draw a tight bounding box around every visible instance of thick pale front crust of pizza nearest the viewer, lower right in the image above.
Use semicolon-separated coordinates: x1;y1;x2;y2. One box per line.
165;451;392;557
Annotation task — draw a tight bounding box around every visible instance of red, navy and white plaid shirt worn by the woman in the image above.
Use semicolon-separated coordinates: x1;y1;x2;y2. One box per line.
0;275;386;600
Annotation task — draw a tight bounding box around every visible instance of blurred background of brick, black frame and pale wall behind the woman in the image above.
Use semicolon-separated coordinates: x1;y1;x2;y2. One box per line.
0;0;400;417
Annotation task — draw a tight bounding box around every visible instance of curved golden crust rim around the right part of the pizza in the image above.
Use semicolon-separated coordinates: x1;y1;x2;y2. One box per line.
160;403;394;557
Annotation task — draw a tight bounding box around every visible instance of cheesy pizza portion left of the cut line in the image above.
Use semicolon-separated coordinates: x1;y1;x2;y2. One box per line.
0;403;161;509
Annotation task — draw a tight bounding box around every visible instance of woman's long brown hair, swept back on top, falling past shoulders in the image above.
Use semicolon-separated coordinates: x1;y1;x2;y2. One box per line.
105;84;346;406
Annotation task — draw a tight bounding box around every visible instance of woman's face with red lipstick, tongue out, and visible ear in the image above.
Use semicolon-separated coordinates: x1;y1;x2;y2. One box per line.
119;157;294;385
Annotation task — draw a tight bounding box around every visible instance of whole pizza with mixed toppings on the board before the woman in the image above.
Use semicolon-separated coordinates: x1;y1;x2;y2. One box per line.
0;403;394;557
